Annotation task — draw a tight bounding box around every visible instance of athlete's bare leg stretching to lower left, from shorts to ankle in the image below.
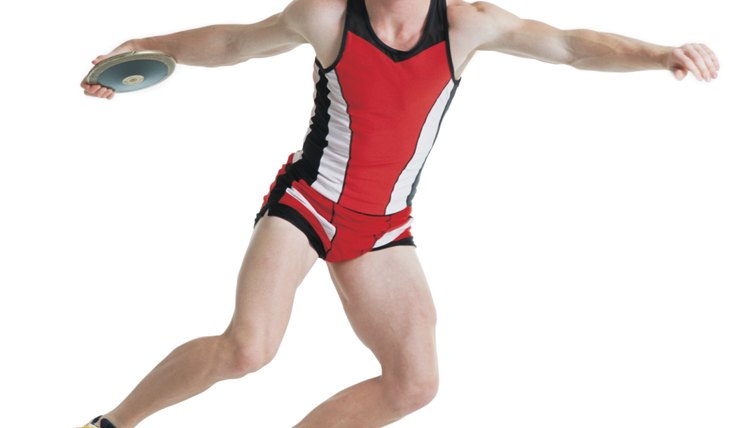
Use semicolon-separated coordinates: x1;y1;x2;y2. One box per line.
98;217;317;428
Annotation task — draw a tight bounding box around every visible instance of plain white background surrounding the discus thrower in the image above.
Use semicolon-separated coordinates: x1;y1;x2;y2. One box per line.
0;0;750;428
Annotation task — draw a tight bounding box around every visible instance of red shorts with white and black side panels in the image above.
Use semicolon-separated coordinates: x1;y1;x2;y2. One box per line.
255;154;414;262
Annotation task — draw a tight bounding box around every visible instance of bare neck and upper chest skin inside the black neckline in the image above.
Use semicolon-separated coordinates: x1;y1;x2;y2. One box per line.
365;0;430;50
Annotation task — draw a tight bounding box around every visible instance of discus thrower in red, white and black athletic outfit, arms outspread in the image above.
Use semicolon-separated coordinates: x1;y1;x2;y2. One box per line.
82;0;719;428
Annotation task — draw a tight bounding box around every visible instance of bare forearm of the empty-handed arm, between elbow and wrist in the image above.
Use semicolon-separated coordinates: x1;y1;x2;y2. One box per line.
563;30;674;71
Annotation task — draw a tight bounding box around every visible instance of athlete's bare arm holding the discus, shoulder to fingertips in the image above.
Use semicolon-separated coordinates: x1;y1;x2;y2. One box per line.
81;0;344;98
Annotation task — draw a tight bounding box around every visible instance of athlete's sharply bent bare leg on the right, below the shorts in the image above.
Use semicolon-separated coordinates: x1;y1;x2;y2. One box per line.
298;246;438;428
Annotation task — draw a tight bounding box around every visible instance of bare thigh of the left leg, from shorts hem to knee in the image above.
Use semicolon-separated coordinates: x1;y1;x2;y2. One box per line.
230;216;317;342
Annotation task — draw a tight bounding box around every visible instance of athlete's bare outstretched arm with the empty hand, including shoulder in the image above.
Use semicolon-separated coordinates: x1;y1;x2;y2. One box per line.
462;2;719;82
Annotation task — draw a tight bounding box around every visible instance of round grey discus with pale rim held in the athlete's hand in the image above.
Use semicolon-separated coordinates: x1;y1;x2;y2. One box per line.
86;51;177;92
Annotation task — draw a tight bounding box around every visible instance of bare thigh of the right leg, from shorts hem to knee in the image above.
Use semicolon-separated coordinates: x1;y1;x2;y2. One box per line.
328;246;436;371
